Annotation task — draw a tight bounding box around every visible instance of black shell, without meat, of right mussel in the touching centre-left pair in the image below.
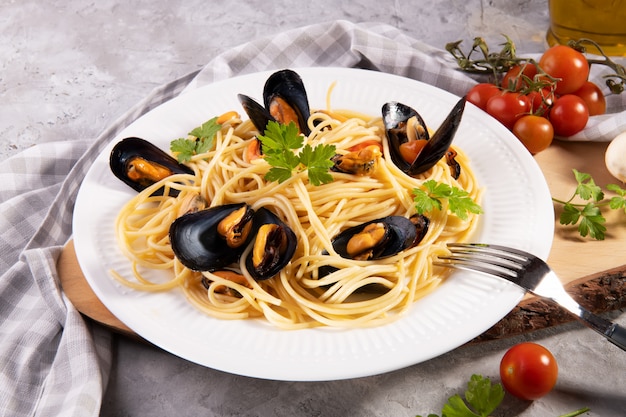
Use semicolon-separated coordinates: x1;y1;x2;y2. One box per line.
245;208;297;281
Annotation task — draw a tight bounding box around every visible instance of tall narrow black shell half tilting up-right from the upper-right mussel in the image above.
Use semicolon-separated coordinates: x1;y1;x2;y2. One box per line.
407;97;465;175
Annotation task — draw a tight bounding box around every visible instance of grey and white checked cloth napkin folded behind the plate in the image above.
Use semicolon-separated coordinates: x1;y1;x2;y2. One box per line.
0;21;626;416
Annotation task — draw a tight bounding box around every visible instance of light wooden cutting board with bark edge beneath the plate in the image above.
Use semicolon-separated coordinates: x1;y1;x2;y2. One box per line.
57;142;626;341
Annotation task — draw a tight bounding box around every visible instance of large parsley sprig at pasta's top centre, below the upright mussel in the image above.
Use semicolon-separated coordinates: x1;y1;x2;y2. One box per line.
258;121;335;185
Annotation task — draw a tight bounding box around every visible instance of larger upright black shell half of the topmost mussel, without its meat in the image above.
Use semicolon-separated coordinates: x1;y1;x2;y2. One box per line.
263;69;311;135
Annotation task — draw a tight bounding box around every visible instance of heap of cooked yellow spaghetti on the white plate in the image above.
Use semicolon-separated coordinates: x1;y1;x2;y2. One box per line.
113;104;481;329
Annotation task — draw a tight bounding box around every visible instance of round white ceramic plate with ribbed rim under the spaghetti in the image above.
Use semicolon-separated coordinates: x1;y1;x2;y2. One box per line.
73;68;553;381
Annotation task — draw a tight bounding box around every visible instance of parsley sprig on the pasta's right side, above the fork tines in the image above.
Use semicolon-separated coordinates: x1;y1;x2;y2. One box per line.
413;180;482;220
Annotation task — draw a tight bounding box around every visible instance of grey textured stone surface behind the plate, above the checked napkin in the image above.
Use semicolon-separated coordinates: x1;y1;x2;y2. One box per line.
0;0;547;159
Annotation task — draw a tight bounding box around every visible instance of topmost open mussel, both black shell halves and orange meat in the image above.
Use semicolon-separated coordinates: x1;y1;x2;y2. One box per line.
237;69;311;135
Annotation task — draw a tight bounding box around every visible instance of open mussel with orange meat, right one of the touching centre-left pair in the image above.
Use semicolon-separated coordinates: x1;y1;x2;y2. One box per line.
245;208;297;281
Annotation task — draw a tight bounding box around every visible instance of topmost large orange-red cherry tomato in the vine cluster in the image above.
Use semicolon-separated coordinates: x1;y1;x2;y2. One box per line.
539;45;589;95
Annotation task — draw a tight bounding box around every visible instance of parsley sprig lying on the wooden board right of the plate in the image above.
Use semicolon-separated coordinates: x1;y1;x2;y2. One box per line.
552;169;626;240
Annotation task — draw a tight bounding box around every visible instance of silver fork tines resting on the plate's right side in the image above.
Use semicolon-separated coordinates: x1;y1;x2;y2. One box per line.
434;243;528;279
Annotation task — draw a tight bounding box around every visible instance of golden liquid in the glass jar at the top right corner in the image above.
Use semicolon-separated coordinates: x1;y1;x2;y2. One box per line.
546;0;626;56
